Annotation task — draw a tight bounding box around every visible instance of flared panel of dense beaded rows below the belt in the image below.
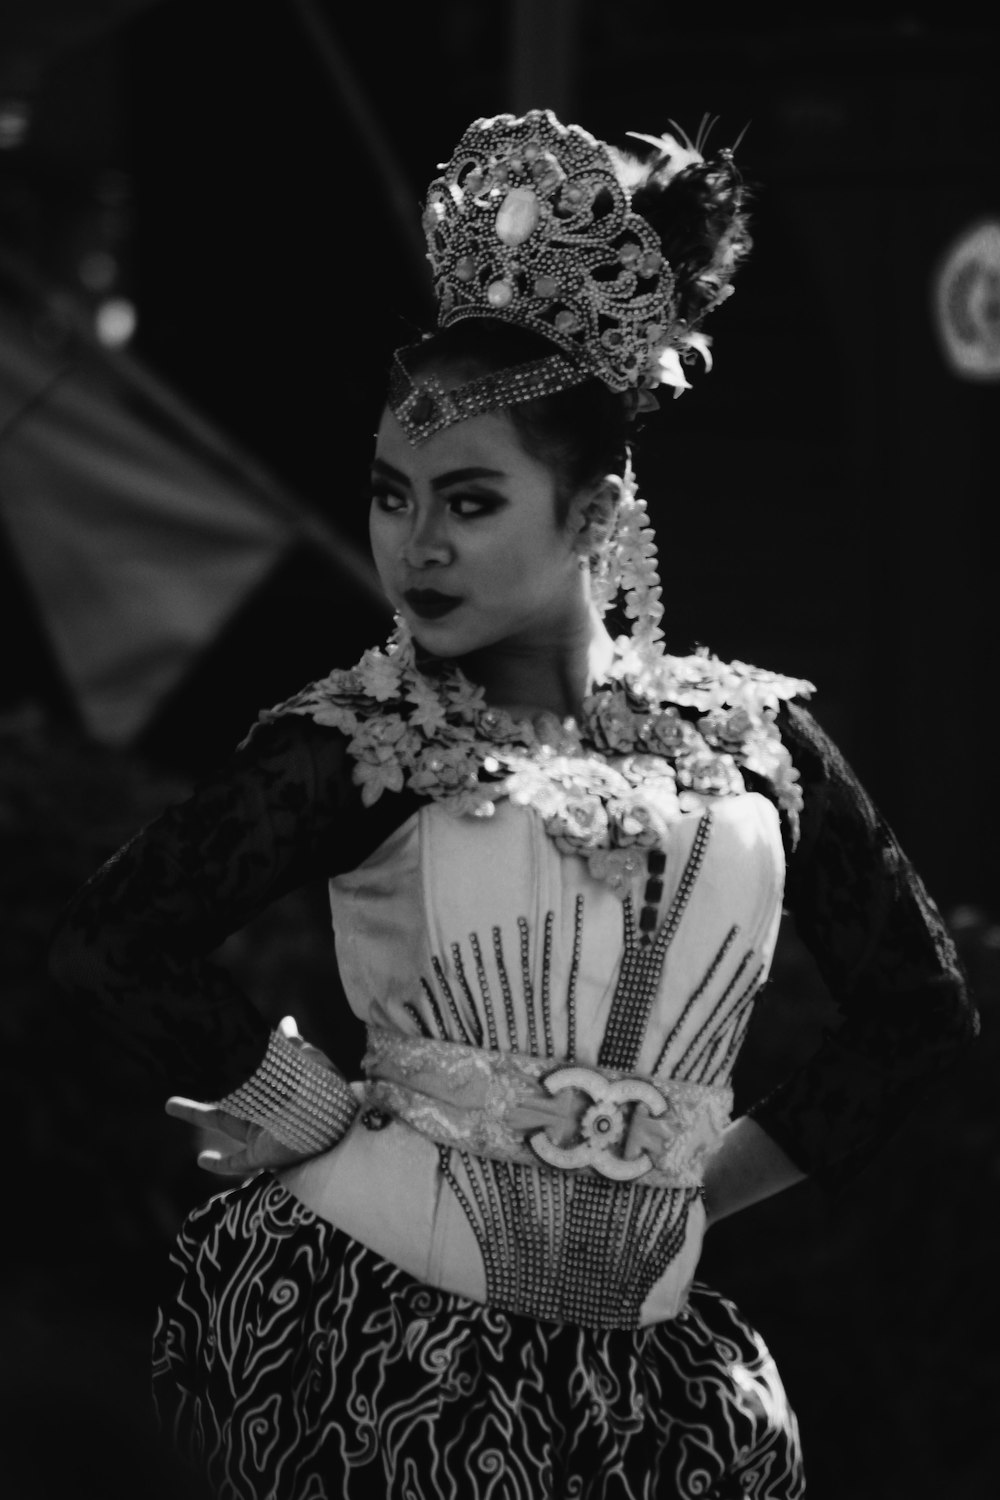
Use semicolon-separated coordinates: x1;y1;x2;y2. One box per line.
439;1146;697;1329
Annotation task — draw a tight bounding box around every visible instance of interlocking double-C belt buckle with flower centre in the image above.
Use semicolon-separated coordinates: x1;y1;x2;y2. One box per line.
528;1068;670;1182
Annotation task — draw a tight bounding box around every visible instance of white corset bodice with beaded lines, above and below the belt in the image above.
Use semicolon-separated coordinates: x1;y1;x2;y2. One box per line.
277;792;784;1326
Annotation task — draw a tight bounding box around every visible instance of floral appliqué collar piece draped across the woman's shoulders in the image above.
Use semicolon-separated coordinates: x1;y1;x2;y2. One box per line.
245;627;814;891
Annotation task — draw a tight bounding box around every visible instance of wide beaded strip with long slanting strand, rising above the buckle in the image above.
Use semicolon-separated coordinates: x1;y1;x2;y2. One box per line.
597;812;712;1068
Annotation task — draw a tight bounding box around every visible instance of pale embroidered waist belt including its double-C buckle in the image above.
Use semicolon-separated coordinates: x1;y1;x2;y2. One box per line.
361;1026;733;1188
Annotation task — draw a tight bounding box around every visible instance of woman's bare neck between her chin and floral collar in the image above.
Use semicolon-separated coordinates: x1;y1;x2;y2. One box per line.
459;611;615;719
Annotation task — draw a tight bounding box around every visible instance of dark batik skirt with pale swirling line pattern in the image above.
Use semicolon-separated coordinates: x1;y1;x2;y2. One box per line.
154;1176;804;1500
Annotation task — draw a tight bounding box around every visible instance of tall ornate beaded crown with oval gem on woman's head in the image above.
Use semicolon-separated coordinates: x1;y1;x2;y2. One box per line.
423;110;721;392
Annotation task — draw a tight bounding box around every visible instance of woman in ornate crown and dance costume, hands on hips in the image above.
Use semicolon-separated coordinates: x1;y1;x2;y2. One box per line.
48;111;973;1500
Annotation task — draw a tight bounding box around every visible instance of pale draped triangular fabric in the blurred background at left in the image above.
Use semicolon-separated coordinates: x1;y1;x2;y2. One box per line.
0;291;386;746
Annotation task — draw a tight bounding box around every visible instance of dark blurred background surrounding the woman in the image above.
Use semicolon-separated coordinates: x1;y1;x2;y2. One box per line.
0;0;1000;1500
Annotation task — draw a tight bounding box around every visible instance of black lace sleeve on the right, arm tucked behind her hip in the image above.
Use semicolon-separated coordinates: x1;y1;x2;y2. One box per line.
750;705;978;1187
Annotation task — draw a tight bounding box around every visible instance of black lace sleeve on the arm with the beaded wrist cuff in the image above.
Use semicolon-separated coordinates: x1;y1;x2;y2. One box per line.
51;714;420;1100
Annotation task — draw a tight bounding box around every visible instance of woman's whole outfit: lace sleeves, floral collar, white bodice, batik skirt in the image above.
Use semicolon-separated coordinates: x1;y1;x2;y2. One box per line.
50;639;973;1500
